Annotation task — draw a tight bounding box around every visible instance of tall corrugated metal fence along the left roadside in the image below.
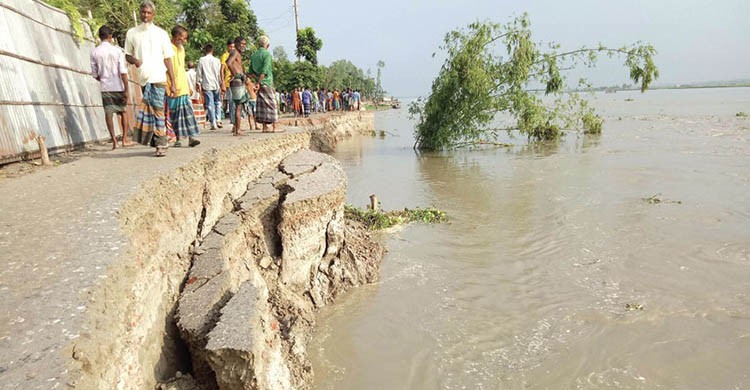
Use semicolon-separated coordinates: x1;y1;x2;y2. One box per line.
0;0;129;164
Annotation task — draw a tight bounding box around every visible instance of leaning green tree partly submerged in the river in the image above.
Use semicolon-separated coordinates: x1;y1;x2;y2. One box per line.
409;14;659;150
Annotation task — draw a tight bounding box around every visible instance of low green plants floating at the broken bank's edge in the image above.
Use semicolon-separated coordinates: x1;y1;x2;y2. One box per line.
344;205;448;230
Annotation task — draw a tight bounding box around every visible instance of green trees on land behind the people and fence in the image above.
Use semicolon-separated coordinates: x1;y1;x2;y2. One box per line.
47;0;376;96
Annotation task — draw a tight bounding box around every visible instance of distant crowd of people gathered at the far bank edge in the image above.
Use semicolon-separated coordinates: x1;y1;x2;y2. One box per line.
277;88;362;117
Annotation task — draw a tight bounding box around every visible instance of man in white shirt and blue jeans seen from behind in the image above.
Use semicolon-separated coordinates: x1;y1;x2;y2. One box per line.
197;43;226;130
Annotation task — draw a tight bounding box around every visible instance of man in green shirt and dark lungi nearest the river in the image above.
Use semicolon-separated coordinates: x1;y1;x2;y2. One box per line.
250;35;278;133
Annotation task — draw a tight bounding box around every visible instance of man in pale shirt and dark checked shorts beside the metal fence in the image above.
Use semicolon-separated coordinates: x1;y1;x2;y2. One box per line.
91;26;131;149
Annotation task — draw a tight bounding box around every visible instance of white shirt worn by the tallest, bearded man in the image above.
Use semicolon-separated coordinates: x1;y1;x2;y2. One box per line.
125;23;174;86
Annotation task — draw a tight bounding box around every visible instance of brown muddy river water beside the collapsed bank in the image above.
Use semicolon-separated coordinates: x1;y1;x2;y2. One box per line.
309;88;750;389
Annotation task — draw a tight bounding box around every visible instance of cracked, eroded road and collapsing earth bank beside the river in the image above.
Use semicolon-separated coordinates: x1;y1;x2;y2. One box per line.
0;113;383;389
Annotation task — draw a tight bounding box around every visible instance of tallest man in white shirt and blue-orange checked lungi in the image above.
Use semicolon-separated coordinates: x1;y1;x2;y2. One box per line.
125;0;177;157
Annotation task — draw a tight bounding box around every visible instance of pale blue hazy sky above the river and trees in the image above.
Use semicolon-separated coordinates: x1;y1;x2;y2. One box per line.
250;0;750;97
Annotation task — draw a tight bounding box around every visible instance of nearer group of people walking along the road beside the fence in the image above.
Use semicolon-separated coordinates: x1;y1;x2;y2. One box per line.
91;0;277;157
